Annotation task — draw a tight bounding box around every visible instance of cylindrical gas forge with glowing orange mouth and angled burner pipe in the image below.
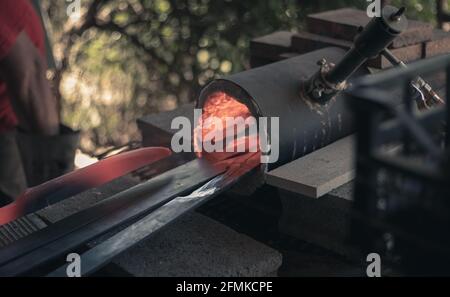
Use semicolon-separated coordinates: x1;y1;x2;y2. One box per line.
194;6;439;170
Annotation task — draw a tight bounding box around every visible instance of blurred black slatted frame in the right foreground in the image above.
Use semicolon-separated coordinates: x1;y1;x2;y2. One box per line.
346;55;450;275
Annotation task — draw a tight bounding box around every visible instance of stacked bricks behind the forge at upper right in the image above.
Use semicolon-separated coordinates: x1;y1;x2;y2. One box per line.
250;8;450;69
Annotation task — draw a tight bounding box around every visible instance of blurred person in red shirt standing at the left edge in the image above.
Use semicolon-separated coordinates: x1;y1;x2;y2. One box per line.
0;0;60;206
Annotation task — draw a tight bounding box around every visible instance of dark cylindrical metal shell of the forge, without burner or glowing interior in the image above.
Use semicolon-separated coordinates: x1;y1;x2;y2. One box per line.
197;47;368;170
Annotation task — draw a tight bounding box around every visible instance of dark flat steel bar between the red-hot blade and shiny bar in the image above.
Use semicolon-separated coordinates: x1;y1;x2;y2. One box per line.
0;159;225;276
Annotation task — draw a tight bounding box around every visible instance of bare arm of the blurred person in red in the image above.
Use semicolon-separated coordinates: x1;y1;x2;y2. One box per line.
0;32;59;135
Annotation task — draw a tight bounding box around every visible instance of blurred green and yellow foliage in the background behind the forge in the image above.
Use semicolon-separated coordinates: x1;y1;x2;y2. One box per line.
40;0;450;162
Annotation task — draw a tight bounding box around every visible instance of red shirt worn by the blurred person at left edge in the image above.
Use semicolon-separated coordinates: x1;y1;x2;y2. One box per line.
0;0;45;133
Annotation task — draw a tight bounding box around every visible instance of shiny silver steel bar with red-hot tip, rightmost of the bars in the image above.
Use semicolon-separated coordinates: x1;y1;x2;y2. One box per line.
48;154;259;277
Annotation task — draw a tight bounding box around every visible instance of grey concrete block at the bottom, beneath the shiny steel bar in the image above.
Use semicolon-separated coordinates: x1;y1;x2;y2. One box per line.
114;213;282;277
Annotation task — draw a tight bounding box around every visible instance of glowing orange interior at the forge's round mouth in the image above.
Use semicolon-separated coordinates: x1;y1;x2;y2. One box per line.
194;92;259;160
